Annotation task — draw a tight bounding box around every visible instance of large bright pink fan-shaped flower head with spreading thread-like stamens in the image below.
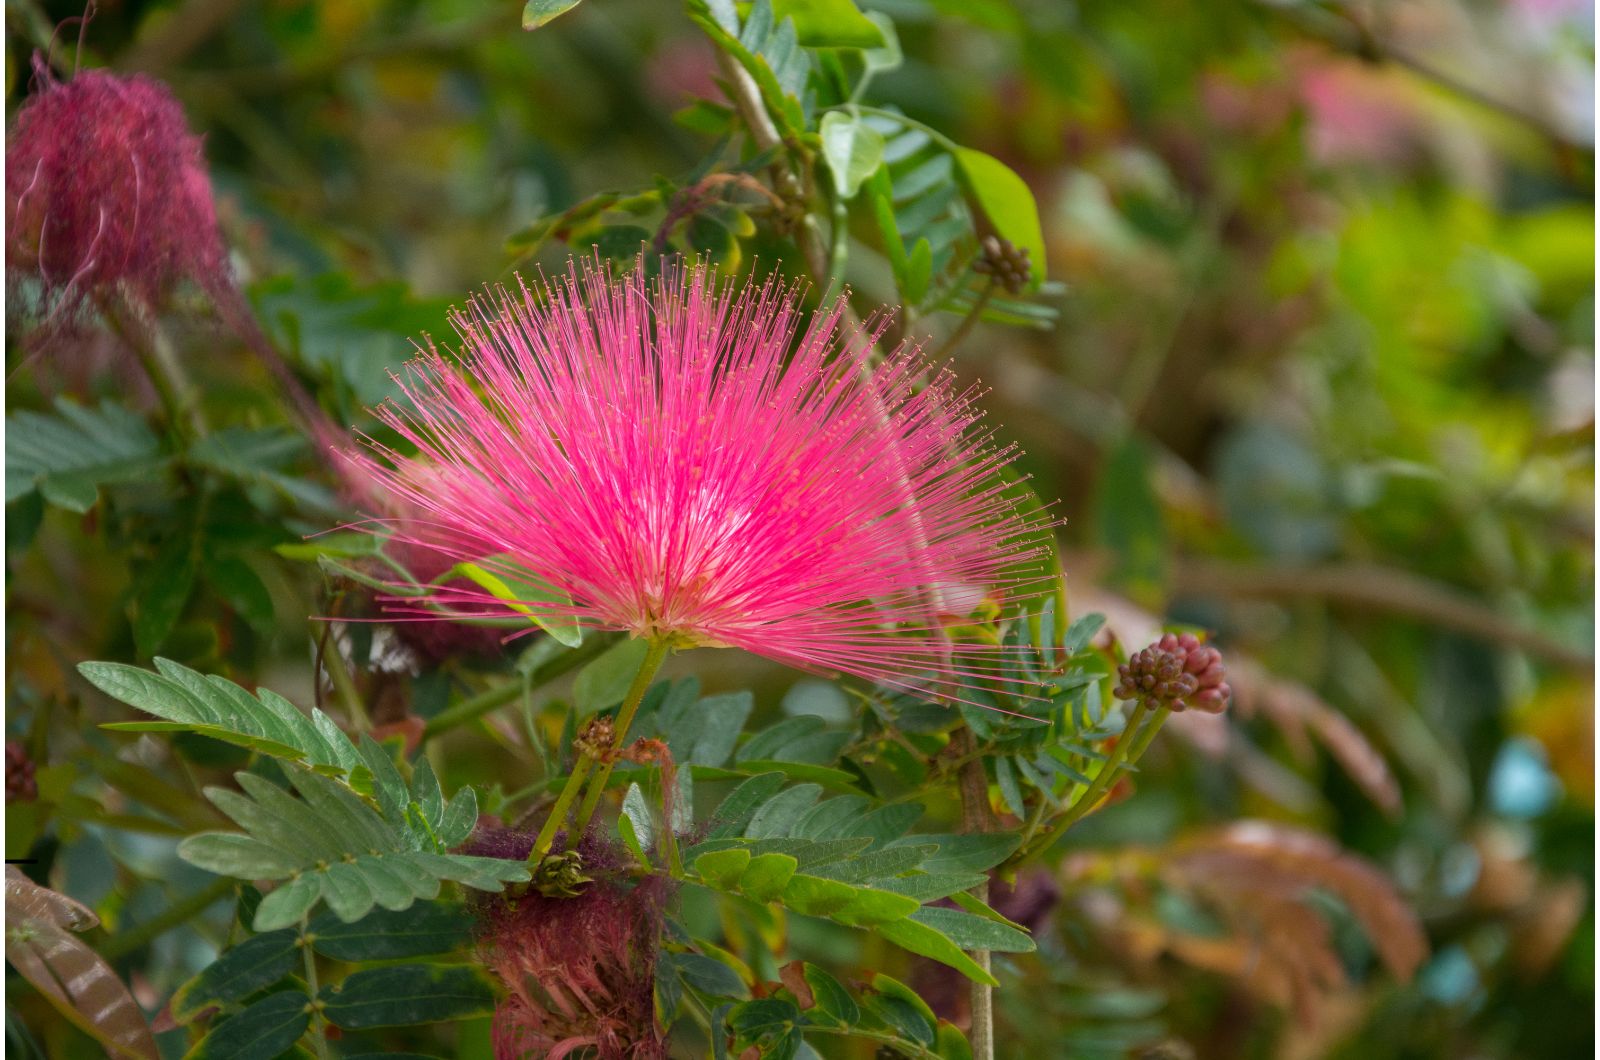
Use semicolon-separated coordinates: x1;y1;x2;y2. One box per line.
350;264;1040;695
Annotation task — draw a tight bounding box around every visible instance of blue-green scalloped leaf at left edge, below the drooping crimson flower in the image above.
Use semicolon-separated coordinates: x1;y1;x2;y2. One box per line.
5;397;166;514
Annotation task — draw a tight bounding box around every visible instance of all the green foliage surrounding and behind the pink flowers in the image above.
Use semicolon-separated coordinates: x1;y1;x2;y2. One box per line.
5;0;1595;1060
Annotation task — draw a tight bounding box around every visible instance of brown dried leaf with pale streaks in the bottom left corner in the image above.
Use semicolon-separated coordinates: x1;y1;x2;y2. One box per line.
5;866;160;1060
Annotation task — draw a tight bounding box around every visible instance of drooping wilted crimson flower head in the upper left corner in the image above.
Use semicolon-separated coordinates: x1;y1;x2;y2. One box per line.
5;59;230;313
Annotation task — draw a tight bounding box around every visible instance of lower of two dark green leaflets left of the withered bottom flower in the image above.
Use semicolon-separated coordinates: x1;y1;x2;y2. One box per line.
318;964;494;1031
